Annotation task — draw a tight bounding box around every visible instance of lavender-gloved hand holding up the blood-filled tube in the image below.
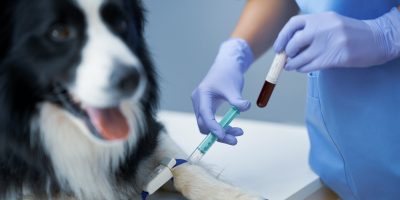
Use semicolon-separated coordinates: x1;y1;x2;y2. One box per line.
274;8;400;72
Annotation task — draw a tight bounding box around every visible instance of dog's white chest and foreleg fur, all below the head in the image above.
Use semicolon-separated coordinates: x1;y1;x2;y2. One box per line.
38;103;262;200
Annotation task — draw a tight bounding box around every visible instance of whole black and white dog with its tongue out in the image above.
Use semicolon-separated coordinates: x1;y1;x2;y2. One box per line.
0;0;260;200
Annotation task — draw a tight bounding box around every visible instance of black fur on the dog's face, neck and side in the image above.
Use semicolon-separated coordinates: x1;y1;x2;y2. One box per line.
0;0;162;199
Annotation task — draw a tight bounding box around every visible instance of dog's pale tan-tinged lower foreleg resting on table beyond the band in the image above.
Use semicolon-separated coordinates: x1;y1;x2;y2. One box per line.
173;164;263;200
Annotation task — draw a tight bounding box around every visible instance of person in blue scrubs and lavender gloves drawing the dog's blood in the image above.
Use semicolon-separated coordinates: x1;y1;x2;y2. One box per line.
192;0;400;200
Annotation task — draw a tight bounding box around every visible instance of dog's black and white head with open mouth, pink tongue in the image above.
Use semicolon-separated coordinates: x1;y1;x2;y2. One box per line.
0;0;157;140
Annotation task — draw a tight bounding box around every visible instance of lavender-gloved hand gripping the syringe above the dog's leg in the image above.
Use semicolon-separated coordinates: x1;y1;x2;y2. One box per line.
192;38;253;145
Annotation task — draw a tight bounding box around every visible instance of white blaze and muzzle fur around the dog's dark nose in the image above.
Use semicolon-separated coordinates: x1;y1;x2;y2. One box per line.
70;0;147;107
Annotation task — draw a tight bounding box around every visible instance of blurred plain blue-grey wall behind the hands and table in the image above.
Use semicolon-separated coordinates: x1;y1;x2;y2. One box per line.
144;0;306;124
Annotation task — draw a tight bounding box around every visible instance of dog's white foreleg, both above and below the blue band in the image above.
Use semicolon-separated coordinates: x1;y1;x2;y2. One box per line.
137;133;263;200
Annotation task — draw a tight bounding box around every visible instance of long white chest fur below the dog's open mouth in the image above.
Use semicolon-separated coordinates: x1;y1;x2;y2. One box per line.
38;103;145;199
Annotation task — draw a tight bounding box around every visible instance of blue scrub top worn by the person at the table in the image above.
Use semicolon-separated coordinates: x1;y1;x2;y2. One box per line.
297;0;400;200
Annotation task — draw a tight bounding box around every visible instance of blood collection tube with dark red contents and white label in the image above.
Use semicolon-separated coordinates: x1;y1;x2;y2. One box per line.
257;52;287;108
